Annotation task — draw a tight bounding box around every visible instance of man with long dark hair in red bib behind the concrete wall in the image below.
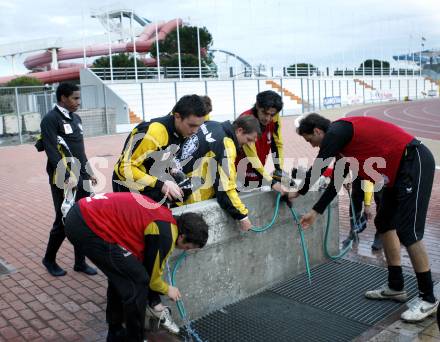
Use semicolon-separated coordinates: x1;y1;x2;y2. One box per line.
235;90;284;193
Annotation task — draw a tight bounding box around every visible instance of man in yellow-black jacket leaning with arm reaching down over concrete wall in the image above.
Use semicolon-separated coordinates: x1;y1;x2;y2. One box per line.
176;116;260;231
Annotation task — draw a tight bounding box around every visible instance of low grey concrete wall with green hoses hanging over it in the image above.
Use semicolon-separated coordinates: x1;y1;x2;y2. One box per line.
164;192;339;319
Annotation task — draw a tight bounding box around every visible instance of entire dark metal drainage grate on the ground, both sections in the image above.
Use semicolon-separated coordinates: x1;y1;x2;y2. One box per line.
186;260;417;342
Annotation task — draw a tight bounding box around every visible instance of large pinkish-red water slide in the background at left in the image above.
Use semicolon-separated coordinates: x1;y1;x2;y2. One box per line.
0;19;182;84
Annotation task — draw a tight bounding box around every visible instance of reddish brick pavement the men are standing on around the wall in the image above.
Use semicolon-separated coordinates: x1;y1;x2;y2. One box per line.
0;105;440;341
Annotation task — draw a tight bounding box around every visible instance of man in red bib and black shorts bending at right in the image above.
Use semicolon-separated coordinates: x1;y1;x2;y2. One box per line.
291;113;438;322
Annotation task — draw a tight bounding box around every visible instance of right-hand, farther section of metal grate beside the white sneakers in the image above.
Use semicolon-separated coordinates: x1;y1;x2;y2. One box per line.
271;260;417;325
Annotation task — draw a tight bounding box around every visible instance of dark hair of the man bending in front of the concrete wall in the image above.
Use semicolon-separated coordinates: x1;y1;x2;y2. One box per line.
175;213;208;248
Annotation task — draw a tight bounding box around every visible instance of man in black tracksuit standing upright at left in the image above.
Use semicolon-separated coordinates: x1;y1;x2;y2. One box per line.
37;83;96;276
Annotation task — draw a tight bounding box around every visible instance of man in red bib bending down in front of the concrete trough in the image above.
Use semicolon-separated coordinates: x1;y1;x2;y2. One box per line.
66;192;208;342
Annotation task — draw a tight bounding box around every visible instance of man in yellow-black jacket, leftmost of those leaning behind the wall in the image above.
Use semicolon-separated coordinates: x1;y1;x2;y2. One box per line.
113;95;206;201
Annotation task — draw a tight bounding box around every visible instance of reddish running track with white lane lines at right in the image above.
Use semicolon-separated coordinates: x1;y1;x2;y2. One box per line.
346;99;440;140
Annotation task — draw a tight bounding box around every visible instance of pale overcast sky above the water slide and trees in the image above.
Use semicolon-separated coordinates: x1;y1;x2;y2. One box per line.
0;0;440;76
